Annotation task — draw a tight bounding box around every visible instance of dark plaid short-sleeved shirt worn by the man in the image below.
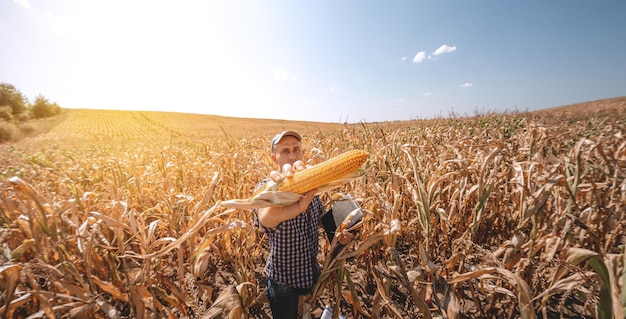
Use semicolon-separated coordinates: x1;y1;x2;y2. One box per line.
255;180;324;289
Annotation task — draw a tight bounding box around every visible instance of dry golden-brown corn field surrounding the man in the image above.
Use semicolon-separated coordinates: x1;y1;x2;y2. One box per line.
0;98;626;318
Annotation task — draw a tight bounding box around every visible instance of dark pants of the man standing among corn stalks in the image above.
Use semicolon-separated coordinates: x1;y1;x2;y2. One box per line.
267;278;310;319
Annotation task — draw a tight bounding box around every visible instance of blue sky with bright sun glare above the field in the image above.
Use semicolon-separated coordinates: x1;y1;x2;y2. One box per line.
0;0;626;122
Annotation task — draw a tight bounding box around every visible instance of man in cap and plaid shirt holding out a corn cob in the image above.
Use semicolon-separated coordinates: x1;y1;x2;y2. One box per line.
256;131;354;319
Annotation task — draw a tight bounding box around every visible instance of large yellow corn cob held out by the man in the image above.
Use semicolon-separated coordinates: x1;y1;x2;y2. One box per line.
276;150;368;194
